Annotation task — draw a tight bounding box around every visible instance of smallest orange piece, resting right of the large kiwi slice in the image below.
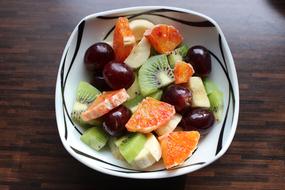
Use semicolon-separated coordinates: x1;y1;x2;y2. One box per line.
174;61;194;84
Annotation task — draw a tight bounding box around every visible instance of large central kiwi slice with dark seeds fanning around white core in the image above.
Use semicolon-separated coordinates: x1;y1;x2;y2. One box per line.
138;55;174;96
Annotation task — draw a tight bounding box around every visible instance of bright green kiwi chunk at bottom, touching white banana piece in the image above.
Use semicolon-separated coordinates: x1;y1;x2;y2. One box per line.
119;133;147;164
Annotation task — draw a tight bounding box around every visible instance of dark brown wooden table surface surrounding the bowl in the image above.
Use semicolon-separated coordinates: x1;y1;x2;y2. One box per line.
0;0;285;190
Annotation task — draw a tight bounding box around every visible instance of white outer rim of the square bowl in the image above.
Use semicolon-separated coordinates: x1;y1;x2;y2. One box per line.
55;6;239;179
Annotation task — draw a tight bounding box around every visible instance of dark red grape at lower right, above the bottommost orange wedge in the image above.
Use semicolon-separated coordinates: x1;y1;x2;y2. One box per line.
179;108;215;131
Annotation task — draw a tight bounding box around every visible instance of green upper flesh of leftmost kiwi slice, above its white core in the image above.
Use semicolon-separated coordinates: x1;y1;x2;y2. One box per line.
76;81;101;104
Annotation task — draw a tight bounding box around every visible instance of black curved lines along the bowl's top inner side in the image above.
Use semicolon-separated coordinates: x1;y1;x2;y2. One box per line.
97;9;215;40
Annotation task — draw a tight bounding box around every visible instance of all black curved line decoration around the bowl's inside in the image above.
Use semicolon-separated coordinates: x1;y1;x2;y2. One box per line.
58;9;235;173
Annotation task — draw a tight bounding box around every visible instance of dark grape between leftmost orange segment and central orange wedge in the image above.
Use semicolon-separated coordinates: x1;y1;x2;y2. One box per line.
103;106;132;136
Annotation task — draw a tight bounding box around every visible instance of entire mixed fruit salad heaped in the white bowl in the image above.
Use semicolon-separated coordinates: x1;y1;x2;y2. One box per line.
71;17;223;169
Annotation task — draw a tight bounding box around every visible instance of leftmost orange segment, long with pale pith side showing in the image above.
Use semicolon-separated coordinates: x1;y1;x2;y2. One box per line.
81;88;129;121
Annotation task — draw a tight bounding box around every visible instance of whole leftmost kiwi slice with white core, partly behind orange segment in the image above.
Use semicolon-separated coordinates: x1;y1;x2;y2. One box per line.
71;81;102;128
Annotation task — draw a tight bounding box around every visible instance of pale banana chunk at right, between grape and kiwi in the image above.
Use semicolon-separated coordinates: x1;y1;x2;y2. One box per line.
188;77;210;108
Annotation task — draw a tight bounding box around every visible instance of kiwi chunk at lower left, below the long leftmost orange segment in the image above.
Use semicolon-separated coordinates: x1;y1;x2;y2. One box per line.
80;127;109;151
